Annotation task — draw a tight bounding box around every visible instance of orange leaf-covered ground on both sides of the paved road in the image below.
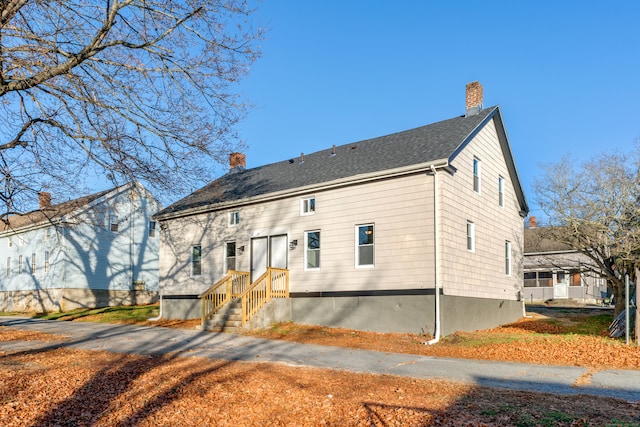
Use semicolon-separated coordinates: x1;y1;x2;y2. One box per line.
0;308;640;427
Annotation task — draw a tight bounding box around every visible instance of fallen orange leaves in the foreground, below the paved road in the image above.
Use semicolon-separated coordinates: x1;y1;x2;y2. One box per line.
0;348;640;427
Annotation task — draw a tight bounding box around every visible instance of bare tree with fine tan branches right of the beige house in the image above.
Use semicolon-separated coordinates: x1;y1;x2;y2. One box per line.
535;147;640;314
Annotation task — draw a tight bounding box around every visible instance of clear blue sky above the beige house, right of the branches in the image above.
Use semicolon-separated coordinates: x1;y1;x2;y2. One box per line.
239;0;640;219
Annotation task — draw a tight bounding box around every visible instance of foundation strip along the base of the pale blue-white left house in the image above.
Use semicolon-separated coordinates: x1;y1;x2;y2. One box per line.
0;288;158;312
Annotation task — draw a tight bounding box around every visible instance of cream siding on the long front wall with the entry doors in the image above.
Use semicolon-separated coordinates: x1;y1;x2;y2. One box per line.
160;174;434;294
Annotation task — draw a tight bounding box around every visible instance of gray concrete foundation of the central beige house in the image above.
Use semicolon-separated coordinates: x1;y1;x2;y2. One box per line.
163;295;523;336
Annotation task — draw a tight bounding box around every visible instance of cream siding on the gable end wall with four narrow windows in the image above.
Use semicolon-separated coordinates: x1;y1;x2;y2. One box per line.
441;121;523;300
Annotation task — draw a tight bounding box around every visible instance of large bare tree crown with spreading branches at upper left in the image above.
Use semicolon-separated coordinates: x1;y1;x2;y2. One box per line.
0;0;261;218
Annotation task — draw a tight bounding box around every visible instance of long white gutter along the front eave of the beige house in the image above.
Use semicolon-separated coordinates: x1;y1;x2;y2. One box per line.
153;159;450;221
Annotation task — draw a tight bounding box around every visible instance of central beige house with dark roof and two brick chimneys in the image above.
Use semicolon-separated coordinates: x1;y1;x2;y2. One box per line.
156;82;528;336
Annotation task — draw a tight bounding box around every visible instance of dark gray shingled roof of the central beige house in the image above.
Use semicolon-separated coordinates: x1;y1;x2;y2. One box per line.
156;106;526;219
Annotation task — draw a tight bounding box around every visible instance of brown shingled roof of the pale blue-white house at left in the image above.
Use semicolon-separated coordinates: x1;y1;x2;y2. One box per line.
0;188;114;233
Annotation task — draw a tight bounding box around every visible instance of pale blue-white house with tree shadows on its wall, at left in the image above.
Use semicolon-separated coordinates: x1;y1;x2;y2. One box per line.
0;183;161;311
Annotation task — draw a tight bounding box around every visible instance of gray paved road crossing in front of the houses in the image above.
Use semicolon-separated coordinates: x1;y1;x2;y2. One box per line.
0;316;640;401
